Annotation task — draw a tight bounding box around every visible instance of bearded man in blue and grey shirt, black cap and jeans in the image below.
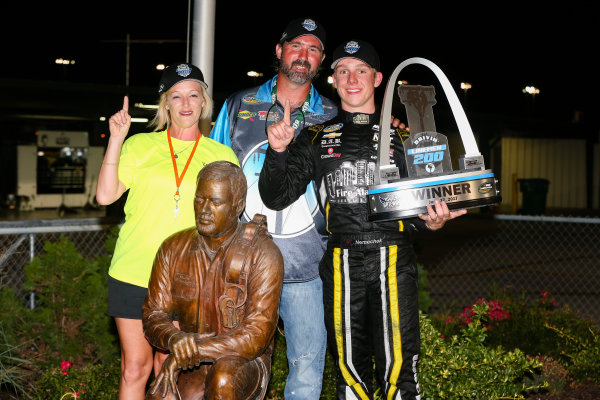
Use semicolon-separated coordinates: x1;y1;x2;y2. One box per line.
210;18;337;400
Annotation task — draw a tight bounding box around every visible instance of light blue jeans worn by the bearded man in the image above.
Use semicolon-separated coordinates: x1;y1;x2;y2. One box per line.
279;278;327;400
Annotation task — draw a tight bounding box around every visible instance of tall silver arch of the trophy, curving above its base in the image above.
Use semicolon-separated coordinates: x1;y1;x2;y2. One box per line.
374;57;482;184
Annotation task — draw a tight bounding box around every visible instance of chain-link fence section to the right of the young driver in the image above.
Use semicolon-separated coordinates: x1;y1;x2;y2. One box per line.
416;215;600;322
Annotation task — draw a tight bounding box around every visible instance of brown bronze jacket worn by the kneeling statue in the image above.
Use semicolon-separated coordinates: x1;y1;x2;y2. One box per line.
143;223;283;366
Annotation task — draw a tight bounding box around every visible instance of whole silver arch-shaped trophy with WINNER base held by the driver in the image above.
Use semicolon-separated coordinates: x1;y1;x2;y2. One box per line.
367;57;502;221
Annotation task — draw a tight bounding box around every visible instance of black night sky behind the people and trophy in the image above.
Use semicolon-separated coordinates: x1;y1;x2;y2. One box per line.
0;0;599;126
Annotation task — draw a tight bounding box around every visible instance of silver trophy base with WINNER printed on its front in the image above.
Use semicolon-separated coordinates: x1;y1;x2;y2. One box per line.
367;170;502;221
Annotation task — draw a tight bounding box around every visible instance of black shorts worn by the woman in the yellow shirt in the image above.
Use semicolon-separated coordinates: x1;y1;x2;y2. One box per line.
107;276;148;320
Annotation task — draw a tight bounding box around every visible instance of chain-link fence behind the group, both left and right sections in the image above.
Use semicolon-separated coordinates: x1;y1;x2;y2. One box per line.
0;213;600;321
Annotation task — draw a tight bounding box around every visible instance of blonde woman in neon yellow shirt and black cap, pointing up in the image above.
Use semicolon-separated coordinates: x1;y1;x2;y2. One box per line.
96;63;239;400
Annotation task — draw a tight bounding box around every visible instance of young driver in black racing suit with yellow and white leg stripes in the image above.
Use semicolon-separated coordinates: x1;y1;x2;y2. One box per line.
259;40;466;400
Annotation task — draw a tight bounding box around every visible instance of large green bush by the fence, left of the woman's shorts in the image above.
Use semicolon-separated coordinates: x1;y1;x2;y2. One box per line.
18;237;118;364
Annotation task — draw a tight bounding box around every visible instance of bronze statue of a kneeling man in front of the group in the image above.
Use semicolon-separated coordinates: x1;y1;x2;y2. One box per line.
143;161;283;399
